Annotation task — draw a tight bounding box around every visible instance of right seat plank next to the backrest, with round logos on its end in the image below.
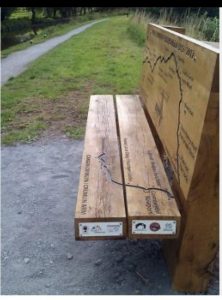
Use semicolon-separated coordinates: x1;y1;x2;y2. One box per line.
116;95;180;238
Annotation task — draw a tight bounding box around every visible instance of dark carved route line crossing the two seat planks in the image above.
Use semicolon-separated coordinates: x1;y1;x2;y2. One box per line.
97;152;174;198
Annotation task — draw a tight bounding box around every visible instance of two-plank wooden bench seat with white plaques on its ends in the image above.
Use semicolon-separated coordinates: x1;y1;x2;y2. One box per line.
75;95;180;240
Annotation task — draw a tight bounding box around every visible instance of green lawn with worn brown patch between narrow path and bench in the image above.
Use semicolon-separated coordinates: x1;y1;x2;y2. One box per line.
2;16;143;144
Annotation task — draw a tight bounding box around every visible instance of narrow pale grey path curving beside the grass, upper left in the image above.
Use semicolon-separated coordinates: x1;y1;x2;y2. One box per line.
1;19;106;85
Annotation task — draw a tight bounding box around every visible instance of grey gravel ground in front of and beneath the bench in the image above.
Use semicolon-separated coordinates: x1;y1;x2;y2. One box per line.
2;137;218;295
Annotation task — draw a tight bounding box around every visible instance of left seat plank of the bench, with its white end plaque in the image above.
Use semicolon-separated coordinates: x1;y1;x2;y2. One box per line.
75;95;126;239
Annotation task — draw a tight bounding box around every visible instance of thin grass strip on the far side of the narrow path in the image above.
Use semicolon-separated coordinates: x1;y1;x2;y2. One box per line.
1;13;109;58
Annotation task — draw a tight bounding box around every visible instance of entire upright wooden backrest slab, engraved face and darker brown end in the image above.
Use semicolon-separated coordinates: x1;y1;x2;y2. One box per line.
141;25;219;292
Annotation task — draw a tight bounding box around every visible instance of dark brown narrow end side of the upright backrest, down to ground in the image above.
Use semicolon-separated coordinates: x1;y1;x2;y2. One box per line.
165;55;219;292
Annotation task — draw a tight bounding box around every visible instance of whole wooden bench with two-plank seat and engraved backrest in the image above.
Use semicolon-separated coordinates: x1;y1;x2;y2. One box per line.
75;24;219;292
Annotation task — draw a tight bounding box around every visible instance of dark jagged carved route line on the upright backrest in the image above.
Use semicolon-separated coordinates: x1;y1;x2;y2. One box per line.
143;47;183;183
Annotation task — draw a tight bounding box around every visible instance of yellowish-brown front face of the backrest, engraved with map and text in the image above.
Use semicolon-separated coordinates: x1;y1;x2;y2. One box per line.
141;24;218;198
